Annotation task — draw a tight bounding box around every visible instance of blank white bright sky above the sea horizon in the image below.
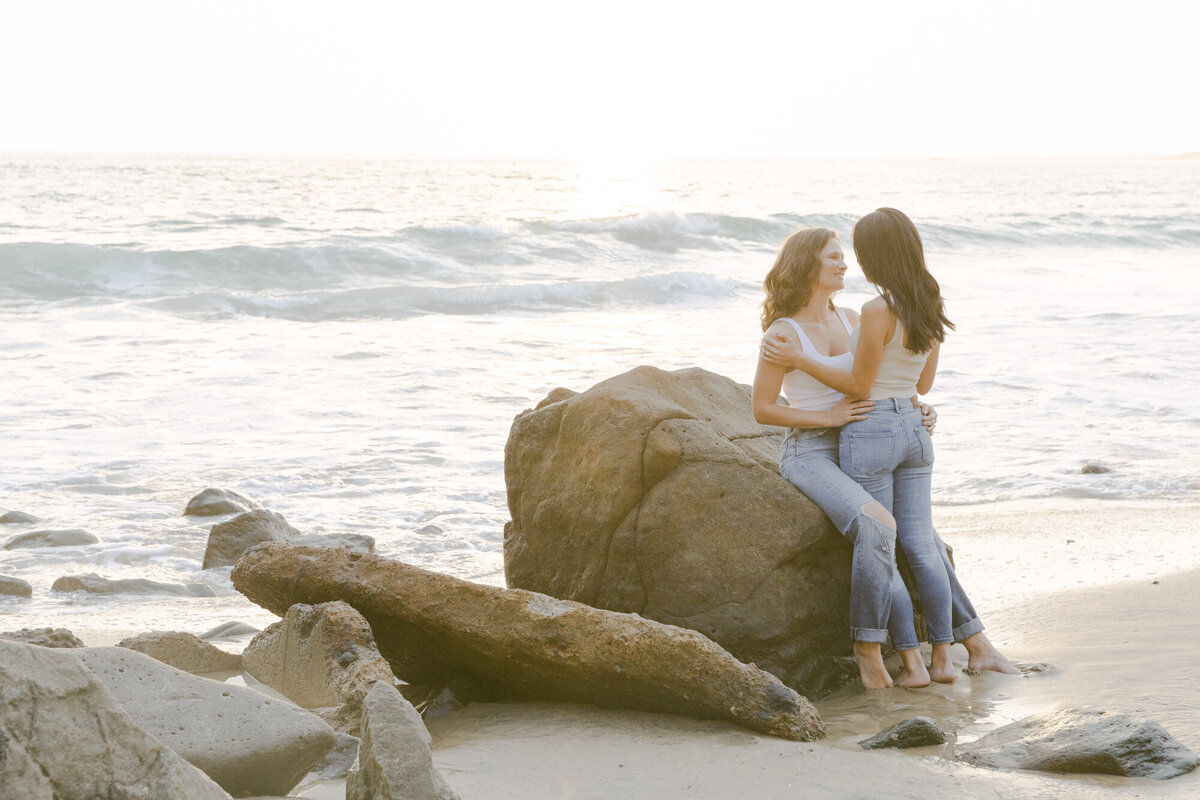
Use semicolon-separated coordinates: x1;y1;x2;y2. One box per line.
0;0;1200;158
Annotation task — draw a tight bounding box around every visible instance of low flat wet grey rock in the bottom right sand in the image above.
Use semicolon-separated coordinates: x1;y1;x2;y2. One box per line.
956;709;1200;780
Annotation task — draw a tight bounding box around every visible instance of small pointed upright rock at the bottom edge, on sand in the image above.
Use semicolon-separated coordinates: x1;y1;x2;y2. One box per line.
346;682;458;800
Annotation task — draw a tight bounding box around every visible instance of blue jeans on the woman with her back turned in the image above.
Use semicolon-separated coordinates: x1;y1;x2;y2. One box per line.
839;397;983;650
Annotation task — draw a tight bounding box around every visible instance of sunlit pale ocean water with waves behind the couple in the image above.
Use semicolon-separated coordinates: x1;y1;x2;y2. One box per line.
0;154;1200;632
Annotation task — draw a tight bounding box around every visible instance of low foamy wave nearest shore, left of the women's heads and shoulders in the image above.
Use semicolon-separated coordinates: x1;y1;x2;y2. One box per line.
146;272;751;321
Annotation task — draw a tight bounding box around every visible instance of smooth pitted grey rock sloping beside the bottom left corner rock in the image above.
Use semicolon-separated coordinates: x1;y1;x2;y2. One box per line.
78;648;336;796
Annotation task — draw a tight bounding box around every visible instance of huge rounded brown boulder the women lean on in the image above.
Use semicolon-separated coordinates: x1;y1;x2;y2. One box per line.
504;367;857;697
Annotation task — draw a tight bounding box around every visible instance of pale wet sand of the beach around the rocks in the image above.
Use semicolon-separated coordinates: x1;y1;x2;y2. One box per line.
410;504;1200;800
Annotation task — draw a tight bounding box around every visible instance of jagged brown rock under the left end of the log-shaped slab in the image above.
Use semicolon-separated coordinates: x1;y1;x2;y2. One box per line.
241;601;395;733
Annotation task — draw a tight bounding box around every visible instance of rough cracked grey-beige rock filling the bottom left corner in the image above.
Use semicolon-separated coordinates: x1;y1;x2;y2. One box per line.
0;642;229;800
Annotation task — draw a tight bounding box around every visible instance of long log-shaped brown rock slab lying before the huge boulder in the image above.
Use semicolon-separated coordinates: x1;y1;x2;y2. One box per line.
233;542;824;740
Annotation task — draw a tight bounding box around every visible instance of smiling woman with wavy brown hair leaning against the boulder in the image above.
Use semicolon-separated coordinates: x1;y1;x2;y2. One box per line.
752;228;936;688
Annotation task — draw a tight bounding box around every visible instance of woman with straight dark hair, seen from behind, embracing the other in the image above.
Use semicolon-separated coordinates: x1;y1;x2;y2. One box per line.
760;209;1016;684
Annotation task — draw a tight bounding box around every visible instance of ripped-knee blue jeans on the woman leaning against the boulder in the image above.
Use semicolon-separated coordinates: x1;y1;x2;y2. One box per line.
779;428;919;650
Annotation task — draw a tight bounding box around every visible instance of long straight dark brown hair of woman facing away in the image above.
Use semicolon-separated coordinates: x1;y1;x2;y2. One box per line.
854;209;954;353
